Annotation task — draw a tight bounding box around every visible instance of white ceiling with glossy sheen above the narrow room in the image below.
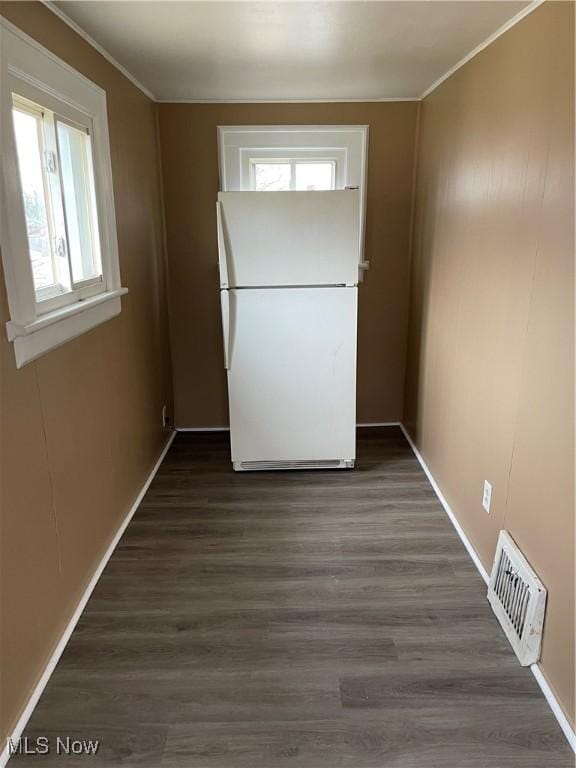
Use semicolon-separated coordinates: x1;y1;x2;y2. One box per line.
54;0;531;101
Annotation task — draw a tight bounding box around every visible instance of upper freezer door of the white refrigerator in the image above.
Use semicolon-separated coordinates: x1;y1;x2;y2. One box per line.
218;190;361;288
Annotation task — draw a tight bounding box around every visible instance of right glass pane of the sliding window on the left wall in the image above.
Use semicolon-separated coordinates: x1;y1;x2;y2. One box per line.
57;121;101;283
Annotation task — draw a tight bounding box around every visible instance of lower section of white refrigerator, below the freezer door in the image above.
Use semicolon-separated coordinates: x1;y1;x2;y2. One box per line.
227;287;358;470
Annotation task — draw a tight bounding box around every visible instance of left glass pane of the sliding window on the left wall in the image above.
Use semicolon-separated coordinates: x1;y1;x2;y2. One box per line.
13;109;57;293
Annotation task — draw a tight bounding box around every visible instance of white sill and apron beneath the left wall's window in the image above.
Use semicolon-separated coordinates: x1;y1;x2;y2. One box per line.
6;288;128;368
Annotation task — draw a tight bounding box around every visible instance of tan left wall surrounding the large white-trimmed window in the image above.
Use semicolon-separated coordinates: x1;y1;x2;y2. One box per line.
0;3;171;745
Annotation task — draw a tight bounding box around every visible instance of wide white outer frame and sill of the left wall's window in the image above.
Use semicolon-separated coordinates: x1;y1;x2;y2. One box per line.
0;17;127;368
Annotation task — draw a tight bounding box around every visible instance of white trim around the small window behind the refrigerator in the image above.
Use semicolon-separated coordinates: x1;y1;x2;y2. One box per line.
218;125;368;260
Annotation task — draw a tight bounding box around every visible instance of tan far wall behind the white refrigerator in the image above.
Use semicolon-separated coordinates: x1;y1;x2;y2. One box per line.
159;102;417;427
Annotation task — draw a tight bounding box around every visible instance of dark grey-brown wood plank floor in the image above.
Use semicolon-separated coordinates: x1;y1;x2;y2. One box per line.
16;428;574;768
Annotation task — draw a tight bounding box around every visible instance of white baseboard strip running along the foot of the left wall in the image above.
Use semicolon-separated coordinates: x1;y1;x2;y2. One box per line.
0;432;176;768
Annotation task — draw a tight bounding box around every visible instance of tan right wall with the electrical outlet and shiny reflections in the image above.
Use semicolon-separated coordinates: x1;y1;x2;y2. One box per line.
406;2;574;720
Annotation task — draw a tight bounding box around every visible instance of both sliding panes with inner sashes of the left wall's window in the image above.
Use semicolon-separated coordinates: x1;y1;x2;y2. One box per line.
12;94;105;312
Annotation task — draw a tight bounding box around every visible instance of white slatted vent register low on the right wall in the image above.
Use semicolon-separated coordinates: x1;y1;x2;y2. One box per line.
488;531;546;667
